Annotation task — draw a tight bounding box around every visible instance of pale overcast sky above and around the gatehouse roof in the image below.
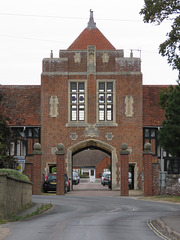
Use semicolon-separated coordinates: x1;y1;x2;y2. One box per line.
0;0;178;85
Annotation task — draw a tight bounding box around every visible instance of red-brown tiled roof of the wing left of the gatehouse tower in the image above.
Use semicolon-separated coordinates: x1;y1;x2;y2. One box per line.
0;86;41;126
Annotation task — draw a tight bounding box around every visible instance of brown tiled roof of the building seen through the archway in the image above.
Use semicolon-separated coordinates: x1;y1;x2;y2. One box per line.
73;150;108;167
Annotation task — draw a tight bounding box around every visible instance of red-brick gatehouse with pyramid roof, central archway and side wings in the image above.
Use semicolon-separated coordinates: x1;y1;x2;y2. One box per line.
0;11;169;189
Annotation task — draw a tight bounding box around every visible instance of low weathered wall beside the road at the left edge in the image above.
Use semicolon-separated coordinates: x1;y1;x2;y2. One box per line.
0;173;32;219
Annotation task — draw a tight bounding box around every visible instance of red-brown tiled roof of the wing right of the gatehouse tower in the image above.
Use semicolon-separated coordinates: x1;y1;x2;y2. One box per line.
143;85;168;126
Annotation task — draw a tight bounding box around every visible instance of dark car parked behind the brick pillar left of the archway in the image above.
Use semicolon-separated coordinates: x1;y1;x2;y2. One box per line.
43;173;70;193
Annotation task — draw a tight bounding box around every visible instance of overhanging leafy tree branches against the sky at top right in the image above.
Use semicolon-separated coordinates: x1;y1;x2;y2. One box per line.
140;0;180;75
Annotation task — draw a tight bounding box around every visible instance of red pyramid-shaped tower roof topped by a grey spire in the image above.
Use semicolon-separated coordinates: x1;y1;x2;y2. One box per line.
67;10;115;50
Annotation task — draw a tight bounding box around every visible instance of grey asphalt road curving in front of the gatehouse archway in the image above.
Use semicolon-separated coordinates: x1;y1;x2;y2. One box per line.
2;190;180;240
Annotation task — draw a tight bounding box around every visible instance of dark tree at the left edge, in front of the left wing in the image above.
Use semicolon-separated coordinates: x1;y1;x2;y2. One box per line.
0;89;15;168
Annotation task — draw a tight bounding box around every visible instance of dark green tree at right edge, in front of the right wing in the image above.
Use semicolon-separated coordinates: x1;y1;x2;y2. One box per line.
159;82;180;157
